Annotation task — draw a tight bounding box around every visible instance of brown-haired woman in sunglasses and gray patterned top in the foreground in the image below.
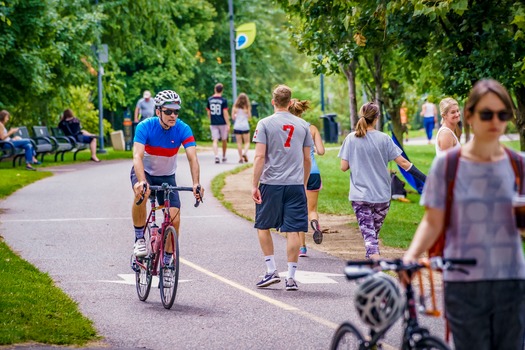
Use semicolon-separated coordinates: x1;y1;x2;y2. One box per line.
403;80;525;350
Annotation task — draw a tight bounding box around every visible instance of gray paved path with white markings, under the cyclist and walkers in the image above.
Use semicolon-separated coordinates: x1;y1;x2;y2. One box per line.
0;150;443;349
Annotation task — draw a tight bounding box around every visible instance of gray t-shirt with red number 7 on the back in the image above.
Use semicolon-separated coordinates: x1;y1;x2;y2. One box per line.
253;112;313;185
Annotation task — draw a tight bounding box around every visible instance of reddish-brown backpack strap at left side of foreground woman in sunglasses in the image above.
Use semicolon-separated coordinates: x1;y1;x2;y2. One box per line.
428;148;461;257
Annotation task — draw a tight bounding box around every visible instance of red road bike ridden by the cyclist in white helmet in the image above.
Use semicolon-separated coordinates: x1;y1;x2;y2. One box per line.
131;183;202;309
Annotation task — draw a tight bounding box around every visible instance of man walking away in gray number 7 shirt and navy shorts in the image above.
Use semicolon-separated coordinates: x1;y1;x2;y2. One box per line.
252;85;313;290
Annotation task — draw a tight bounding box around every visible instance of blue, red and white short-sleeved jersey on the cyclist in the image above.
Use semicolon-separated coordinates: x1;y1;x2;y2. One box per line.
134;118;197;176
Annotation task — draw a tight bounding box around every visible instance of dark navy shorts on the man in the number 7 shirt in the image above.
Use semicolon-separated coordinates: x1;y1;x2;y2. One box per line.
254;184;308;232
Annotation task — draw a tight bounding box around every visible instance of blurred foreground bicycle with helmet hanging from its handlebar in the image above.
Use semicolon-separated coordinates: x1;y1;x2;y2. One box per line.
330;257;476;350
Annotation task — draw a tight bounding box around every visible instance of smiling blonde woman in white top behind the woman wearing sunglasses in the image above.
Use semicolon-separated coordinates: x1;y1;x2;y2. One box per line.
436;97;461;155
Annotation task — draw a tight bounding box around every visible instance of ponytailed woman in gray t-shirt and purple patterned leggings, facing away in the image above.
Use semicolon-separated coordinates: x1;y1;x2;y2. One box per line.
339;102;426;259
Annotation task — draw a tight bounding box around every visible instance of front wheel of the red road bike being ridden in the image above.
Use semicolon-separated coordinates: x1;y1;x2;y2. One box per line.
159;226;179;309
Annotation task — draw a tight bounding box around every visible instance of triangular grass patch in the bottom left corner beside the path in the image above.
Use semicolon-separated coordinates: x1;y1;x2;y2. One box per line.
0;242;99;345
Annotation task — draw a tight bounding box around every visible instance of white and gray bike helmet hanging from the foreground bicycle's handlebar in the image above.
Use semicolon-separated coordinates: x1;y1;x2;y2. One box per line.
354;272;404;332
